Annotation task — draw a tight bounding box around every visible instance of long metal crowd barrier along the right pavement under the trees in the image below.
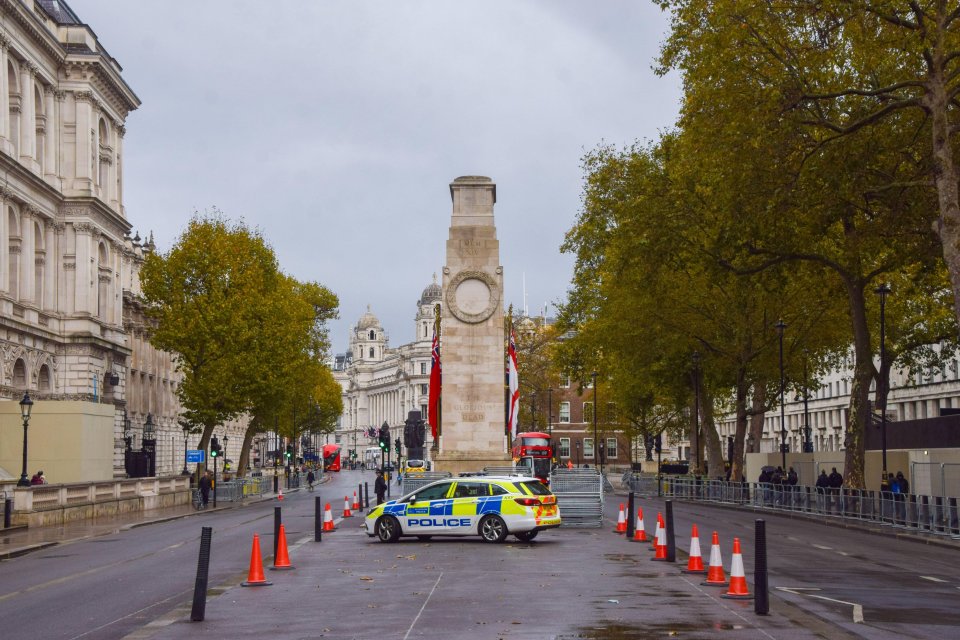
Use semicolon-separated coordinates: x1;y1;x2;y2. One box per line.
644;474;960;539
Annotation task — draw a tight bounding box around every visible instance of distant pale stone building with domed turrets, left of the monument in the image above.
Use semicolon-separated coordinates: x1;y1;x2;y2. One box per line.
332;277;442;459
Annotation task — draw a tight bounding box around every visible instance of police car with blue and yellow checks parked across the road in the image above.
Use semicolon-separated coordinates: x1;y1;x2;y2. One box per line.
364;476;560;542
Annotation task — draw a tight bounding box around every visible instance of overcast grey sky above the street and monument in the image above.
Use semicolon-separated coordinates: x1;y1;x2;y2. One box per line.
68;0;680;352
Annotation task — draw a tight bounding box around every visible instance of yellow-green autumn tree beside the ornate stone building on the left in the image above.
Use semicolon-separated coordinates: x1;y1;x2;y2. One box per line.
140;214;342;474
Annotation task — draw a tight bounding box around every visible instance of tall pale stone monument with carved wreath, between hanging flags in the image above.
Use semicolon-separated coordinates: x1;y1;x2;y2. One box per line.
434;176;510;475
